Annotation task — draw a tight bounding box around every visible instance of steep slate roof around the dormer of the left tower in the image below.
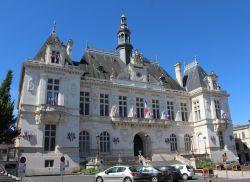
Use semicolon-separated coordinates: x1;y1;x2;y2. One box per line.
34;32;73;65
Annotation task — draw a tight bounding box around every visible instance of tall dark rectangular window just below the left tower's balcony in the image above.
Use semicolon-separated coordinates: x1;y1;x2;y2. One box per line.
44;124;56;151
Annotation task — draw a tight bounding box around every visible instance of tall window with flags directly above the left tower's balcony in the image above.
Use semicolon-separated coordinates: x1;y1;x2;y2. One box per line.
47;79;59;105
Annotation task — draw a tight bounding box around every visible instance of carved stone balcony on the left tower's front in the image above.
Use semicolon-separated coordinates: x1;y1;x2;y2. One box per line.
35;104;66;124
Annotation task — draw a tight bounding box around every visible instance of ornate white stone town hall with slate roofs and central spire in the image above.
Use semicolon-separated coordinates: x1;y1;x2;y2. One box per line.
15;14;236;174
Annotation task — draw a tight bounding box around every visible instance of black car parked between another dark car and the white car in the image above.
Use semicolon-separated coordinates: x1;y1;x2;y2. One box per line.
155;166;182;182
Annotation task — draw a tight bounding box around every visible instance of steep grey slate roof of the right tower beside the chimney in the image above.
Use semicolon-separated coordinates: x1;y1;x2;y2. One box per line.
183;61;208;91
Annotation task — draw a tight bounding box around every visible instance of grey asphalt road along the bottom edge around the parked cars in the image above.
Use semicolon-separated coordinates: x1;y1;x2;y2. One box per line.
23;175;250;182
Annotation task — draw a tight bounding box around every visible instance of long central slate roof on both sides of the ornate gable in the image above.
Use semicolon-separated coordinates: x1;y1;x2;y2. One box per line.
79;48;184;90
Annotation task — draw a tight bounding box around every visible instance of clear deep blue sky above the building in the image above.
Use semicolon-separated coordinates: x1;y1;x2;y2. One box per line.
0;0;250;124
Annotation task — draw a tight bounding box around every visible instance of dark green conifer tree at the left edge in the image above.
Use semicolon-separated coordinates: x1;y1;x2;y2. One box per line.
0;70;20;144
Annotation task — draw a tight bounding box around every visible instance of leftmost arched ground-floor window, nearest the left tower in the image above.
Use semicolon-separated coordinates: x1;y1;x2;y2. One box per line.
79;131;89;156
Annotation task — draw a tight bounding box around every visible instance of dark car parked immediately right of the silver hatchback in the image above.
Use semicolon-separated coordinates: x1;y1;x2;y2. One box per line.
134;166;167;182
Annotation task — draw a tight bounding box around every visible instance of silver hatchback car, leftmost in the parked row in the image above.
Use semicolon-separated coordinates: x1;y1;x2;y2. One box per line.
95;166;137;182
